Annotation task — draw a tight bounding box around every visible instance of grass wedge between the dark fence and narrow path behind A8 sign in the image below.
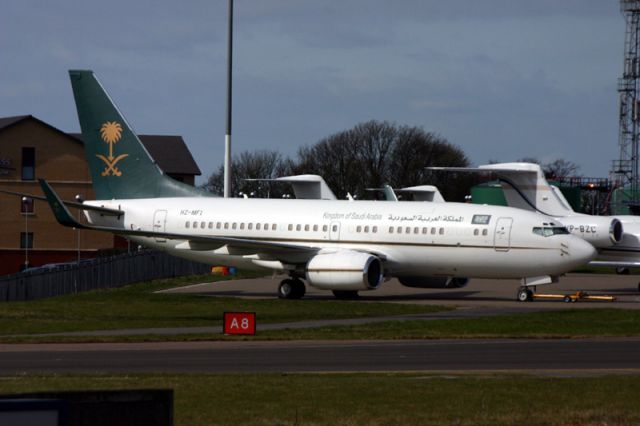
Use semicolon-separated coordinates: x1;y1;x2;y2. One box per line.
0;275;445;339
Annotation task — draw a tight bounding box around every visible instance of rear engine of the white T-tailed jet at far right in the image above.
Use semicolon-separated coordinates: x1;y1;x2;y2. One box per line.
558;215;624;248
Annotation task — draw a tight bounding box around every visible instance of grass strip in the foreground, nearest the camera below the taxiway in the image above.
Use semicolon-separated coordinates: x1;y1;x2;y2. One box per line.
0;374;640;426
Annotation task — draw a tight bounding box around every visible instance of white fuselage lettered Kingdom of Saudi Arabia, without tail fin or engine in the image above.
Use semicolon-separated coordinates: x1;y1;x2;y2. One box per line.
86;198;594;278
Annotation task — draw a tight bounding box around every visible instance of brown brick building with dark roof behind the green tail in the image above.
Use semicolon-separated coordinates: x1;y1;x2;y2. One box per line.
0;115;201;275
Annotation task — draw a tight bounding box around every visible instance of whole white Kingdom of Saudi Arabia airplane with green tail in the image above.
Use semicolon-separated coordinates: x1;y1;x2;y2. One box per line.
35;71;595;300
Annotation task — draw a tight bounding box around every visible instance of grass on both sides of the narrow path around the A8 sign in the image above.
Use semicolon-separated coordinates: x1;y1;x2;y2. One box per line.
0;275;640;343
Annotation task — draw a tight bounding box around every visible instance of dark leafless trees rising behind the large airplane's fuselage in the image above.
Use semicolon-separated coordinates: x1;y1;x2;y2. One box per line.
204;120;475;200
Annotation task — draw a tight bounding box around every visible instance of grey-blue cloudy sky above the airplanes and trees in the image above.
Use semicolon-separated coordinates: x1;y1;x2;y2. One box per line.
0;0;625;184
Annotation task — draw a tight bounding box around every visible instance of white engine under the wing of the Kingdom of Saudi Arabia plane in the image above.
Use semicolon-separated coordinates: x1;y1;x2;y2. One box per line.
306;250;383;290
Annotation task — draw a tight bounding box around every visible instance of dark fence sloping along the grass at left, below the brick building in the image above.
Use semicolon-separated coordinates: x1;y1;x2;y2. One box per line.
0;250;210;302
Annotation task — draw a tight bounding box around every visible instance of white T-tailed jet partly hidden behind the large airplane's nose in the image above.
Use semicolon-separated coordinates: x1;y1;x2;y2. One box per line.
430;163;640;290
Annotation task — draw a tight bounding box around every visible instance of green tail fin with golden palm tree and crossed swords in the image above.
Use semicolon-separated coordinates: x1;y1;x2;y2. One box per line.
69;70;212;200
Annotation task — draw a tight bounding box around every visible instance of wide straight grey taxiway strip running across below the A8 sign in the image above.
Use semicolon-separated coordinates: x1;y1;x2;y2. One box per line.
0;338;640;374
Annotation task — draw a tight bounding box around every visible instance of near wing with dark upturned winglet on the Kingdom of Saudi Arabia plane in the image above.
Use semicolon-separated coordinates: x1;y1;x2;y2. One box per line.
39;179;320;258
